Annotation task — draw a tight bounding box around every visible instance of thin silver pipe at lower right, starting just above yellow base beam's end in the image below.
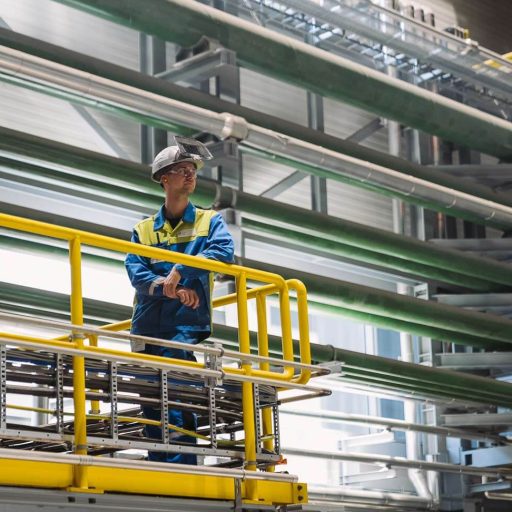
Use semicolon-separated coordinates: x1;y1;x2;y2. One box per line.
283;447;512;480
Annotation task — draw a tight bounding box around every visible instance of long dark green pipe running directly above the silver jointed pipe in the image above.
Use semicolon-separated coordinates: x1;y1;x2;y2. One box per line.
0;27;512;222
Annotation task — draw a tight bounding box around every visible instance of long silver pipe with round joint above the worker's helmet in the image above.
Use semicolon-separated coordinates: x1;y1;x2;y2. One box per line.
0;45;512;228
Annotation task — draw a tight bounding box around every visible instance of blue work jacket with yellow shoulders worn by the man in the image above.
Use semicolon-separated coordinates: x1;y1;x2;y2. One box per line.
125;202;234;350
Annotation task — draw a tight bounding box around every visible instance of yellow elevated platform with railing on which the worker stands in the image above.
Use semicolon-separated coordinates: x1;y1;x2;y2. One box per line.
0;215;329;510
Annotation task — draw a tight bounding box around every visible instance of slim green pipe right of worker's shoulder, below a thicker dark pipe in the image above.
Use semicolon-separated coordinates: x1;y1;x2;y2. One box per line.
242;218;506;292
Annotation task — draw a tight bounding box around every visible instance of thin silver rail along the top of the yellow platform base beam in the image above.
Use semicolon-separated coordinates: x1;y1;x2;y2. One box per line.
0;448;298;482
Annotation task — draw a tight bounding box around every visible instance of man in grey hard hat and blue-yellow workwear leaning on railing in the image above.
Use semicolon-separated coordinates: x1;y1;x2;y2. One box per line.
125;137;234;464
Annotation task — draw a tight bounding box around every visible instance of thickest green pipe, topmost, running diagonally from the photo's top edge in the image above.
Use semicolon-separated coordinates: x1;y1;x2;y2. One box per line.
51;0;512;159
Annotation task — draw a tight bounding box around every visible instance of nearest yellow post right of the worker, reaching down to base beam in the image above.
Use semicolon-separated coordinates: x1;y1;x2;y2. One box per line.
236;273;256;500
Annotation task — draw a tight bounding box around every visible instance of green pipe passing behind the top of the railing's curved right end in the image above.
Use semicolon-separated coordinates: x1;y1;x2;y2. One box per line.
242;258;512;346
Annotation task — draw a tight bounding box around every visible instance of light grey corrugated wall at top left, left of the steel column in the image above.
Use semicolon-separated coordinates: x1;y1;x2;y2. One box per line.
0;0;139;160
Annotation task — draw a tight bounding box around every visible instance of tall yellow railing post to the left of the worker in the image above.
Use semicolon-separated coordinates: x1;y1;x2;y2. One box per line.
69;236;88;489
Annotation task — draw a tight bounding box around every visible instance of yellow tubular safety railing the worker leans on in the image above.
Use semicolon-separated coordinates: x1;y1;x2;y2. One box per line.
0;210;311;489
